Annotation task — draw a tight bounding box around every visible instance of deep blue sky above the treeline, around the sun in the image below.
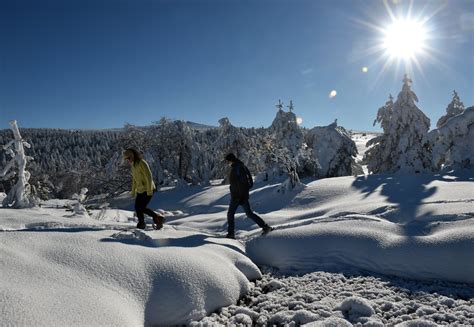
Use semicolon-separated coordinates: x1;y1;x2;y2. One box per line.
0;0;474;130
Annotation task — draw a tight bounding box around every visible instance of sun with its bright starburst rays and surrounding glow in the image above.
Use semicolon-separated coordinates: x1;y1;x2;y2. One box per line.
353;0;447;84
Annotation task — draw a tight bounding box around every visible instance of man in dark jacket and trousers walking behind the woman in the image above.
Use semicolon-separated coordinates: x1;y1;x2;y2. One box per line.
225;153;272;238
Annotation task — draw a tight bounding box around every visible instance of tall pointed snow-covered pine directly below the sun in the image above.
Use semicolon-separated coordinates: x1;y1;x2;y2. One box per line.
364;75;432;173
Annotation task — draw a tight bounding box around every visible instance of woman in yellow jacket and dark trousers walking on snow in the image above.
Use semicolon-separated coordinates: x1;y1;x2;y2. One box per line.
123;148;164;229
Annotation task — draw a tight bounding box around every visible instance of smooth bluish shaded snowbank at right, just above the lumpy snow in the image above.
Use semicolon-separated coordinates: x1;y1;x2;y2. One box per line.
246;217;474;283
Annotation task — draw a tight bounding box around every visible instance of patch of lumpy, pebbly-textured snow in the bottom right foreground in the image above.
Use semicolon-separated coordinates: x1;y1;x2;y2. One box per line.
191;271;474;326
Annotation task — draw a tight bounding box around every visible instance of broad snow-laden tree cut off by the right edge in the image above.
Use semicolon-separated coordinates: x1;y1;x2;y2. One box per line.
429;107;474;169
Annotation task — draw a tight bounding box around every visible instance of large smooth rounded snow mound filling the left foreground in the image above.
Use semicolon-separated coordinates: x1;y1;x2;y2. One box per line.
0;217;261;326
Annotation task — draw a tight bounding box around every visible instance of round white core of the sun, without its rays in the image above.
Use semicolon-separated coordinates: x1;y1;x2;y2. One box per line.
382;19;427;61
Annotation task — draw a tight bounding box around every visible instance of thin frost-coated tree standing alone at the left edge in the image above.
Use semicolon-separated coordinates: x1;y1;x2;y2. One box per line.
1;120;38;208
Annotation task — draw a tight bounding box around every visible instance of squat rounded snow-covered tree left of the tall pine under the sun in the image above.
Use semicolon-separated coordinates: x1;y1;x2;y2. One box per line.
305;120;363;177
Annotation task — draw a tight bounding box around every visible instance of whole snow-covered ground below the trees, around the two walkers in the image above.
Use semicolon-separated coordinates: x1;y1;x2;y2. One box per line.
0;170;474;326
